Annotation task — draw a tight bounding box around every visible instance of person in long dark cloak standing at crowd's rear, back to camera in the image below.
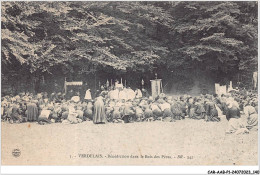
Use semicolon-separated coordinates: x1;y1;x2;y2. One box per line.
93;96;107;124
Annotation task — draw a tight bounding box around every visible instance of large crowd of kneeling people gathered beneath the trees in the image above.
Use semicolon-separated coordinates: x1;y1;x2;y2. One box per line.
1;83;258;133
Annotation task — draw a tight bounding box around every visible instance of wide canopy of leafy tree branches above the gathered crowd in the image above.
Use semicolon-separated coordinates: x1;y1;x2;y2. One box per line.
1;1;257;88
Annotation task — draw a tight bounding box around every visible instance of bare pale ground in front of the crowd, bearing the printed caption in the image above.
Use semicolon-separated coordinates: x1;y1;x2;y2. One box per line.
2;117;258;165
